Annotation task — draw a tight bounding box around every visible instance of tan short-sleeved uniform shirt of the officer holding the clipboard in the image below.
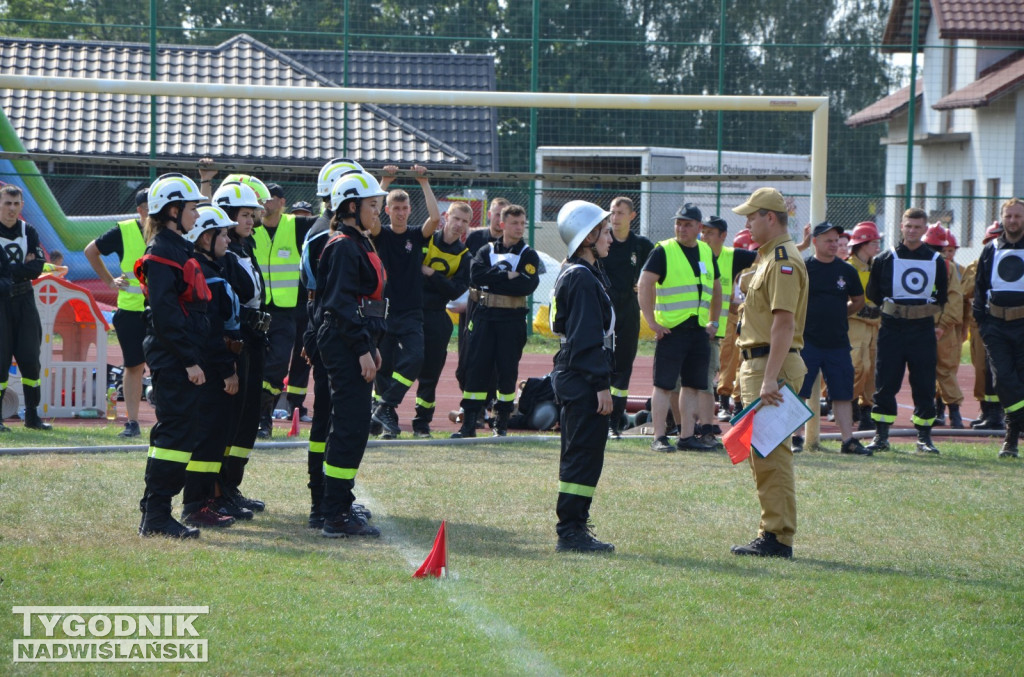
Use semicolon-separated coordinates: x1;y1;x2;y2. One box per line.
736;234;807;350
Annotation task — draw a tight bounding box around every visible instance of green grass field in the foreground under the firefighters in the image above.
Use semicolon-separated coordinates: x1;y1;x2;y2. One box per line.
0;427;1024;675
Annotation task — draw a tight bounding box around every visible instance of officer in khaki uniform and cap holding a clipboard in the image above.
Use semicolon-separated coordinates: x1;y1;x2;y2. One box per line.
732;188;807;557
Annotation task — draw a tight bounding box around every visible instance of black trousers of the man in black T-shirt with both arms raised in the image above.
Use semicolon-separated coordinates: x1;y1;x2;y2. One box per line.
375;308;423;407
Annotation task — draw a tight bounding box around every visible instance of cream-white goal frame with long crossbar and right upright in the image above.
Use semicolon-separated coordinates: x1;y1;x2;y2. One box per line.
0;75;828;223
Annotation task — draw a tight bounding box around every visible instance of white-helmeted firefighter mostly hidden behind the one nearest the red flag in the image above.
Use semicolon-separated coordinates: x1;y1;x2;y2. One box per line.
299;158;371;530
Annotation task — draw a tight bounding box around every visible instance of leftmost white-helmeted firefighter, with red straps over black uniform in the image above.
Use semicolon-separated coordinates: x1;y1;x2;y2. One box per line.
135;174;210;538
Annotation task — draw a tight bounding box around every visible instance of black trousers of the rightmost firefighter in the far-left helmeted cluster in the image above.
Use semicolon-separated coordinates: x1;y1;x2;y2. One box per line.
220;328;265;489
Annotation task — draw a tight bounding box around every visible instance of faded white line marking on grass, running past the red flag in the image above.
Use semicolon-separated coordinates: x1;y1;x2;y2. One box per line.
358;484;561;677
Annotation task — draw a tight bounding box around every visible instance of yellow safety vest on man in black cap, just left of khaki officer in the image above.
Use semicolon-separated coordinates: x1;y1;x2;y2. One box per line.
654;238;715;329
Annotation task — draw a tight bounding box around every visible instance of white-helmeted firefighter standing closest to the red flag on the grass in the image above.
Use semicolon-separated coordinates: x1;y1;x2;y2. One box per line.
307;172;387;538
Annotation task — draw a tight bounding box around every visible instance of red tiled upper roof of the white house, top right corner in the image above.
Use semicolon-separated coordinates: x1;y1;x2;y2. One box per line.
883;0;1024;51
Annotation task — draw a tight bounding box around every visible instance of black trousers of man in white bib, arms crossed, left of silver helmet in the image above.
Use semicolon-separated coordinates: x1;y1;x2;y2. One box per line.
462;306;528;413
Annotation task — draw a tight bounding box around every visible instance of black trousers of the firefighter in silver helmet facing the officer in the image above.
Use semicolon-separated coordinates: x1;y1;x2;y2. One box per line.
551;371;608;536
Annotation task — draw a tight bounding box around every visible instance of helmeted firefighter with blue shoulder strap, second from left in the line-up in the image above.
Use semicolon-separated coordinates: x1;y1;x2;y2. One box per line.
181;205;244;527
